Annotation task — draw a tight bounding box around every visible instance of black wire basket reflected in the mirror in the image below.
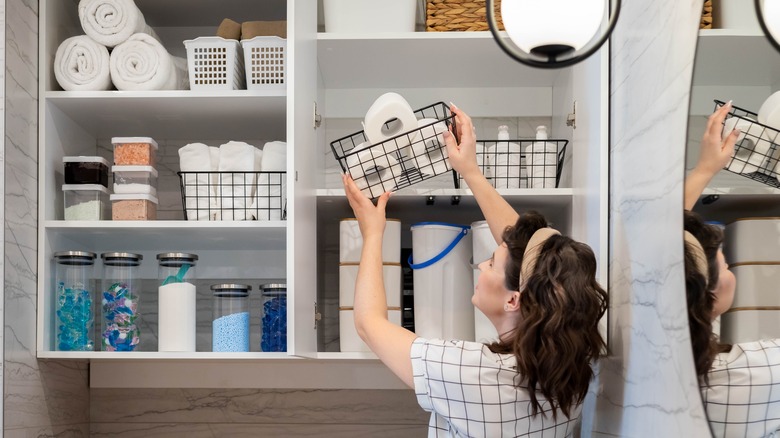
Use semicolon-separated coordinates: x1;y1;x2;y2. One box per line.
715;100;780;187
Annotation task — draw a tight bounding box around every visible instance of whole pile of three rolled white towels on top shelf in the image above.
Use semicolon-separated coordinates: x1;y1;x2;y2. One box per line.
54;0;189;91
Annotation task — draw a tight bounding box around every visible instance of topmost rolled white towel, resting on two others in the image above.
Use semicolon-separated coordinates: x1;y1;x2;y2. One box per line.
79;0;159;47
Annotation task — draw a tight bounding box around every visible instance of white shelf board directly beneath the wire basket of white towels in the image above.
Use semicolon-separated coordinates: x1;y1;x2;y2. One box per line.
43;221;287;251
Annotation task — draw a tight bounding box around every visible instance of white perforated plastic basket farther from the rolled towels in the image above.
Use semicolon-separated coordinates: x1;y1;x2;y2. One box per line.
241;36;287;90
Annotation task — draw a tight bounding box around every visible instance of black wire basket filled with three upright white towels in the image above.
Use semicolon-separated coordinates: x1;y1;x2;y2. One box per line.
179;141;287;221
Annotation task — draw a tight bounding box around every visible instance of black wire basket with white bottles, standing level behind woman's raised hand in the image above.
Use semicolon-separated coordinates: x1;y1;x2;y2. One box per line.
458;139;569;189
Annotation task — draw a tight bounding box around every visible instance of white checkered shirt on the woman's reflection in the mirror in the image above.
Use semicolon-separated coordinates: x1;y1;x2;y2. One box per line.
701;339;780;438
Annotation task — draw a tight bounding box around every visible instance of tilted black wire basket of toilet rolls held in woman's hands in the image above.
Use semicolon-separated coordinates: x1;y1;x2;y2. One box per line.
330;102;458;199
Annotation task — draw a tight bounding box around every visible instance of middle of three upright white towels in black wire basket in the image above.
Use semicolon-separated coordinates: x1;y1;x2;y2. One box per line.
217;141;255;221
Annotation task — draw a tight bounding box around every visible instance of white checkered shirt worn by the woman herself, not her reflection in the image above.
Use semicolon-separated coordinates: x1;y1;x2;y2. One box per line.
411;338;582;438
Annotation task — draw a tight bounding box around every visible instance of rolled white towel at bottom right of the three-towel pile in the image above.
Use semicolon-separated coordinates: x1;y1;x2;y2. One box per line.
110;33;190;90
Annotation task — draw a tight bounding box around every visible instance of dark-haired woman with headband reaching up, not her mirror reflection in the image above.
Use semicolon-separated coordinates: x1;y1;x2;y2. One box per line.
344;106;606;437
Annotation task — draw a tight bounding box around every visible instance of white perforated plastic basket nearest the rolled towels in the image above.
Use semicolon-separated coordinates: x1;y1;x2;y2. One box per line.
184;37;244;90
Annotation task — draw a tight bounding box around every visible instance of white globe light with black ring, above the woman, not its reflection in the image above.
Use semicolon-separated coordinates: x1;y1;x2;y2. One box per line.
486;0;620;68
